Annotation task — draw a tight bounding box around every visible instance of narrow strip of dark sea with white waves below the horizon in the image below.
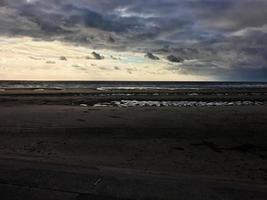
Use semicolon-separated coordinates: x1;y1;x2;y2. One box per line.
0;81;267;90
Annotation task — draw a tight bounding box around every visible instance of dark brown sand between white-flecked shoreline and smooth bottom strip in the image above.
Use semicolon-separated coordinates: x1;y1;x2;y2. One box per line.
0;101;267;184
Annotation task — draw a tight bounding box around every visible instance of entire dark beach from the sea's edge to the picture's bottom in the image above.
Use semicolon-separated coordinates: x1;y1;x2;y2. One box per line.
0;87;267;200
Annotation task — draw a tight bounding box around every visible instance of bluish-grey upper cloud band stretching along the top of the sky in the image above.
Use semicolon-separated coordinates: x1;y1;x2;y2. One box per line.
0;0;267;41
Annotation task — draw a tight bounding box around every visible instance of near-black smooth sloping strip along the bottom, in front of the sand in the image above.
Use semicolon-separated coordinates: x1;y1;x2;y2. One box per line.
0;160;267;200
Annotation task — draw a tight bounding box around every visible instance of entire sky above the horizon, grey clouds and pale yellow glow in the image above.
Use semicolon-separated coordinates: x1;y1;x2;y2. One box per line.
0;0;267;81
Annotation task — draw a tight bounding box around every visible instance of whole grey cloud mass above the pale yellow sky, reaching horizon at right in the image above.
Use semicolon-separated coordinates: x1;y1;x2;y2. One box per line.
0;0;267;81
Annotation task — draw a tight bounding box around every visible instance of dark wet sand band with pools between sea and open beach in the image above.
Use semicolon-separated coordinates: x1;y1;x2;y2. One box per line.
0;88;267;106
